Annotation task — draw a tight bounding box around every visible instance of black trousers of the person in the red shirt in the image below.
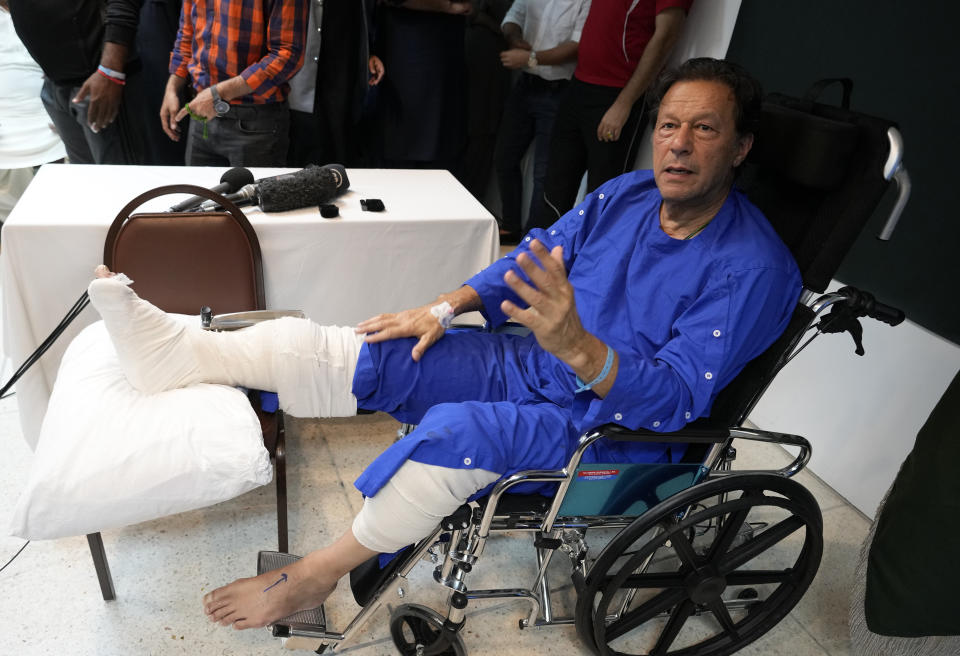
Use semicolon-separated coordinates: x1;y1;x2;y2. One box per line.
527;78;646;229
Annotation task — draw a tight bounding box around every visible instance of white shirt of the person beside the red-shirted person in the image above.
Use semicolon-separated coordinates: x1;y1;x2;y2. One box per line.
502;0;590;80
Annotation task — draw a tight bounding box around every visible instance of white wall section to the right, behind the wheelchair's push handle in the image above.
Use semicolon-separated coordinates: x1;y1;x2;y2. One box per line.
750;282;960;517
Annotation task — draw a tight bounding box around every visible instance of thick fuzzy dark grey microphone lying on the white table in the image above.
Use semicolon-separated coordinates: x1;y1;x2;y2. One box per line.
199;164;350;212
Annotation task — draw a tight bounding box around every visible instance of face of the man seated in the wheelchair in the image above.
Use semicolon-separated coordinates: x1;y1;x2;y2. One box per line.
653;80;753;208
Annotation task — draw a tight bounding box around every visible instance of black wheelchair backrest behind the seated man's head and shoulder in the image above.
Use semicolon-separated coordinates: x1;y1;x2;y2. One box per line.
738;80;896;293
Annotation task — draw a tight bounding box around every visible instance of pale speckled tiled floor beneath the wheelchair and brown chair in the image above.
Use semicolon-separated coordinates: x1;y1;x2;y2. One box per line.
0;398;868;656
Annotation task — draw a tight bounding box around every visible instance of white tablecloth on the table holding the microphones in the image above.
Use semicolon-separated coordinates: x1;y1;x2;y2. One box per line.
0;164;499;447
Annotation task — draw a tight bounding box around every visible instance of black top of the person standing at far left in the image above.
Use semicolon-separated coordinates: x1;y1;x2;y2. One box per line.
9;0;140;84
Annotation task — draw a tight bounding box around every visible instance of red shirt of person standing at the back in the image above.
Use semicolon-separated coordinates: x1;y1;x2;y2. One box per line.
573;0;693;88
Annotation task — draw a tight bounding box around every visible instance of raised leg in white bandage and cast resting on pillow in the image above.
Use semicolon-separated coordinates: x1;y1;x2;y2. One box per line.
88;277;363;417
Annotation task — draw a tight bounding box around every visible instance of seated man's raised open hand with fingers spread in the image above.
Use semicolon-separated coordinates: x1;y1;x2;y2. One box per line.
500;239;588;364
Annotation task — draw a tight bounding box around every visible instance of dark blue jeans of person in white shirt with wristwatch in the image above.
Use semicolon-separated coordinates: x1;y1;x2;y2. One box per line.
494;73;567;232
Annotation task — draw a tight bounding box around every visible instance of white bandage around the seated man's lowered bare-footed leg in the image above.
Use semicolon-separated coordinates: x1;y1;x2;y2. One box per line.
353;460;501;553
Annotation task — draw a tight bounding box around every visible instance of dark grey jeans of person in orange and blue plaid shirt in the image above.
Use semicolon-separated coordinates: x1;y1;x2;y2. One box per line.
187;101;290;166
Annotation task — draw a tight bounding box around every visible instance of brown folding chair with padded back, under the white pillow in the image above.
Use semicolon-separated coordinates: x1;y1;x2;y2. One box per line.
87;185;287;599
